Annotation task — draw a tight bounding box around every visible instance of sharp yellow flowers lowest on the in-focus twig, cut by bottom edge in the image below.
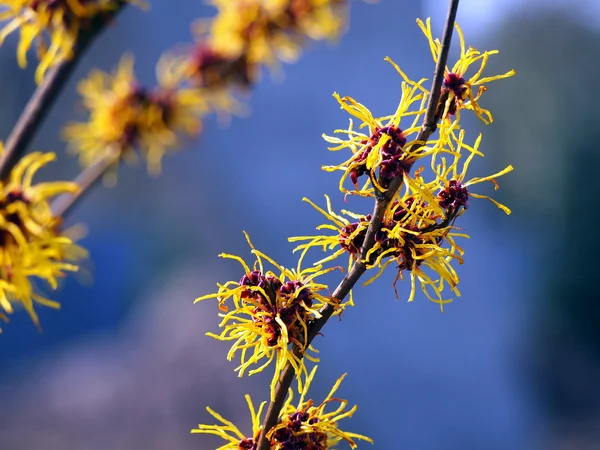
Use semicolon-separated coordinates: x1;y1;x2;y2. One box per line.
192;367;373;450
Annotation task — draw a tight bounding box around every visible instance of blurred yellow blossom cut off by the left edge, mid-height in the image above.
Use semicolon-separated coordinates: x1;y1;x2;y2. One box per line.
0;148;86;326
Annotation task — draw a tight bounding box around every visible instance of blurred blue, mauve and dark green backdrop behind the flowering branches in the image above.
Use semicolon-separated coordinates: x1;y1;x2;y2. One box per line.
0;0;600;450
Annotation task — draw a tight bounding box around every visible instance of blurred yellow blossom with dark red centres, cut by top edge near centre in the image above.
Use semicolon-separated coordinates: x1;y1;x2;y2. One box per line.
169;0;348;89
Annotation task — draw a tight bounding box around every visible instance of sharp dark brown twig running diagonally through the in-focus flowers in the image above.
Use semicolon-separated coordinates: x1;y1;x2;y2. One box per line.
257;0;459;450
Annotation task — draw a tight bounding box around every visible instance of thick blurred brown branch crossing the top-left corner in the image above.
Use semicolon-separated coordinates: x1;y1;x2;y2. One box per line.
0;1;126;180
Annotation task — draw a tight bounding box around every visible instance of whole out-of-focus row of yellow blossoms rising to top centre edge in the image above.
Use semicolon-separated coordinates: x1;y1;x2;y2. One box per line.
64;0;347;179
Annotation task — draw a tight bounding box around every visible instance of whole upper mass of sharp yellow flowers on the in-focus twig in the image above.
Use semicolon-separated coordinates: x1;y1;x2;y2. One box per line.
290;21;514;308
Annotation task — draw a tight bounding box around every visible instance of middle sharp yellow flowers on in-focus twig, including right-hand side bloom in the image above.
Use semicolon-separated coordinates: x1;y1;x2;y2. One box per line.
289;131;513;308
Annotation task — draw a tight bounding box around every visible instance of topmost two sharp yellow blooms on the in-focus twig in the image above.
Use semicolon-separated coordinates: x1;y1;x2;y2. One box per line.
323;19;515;196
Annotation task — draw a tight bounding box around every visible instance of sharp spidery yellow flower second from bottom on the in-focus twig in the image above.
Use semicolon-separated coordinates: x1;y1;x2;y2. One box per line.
196;234;344;395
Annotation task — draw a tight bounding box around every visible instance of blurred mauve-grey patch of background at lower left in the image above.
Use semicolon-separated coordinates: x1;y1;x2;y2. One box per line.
0;265;267;450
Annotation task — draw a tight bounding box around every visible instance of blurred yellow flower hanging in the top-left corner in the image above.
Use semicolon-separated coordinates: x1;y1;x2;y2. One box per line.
0;0;146;84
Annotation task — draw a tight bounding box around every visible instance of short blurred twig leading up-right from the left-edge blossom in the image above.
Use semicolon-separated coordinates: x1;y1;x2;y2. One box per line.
51;148;121;219
